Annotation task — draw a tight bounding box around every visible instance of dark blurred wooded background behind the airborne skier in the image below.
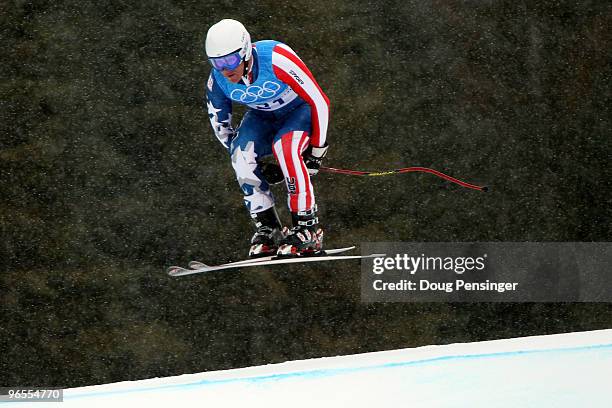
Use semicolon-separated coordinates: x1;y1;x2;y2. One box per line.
0;0;612;386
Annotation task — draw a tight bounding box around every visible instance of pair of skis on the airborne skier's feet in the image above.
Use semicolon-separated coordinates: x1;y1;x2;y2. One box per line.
167;246;384;276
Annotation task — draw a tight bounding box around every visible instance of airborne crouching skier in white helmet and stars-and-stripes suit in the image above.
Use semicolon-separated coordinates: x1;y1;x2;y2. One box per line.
205;19;329;257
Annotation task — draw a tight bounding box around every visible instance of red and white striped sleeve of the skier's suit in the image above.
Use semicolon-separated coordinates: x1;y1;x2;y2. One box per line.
272;44;329;147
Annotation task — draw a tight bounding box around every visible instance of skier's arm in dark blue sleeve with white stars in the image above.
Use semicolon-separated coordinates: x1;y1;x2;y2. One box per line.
206;72;234;151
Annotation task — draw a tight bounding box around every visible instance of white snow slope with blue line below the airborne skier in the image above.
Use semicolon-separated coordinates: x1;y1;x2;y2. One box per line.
9;330;612;408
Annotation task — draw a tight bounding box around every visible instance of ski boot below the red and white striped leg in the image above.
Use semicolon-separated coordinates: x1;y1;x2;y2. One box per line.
277;207;323;256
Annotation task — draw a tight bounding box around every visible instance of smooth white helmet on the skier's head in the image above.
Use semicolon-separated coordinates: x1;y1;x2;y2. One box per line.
206;18;252;61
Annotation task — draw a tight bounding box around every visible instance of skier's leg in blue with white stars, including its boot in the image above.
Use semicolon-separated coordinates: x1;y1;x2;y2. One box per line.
230;111;282;257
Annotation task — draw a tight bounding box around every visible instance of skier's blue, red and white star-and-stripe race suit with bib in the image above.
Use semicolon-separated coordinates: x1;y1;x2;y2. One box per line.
206;40;329;213
